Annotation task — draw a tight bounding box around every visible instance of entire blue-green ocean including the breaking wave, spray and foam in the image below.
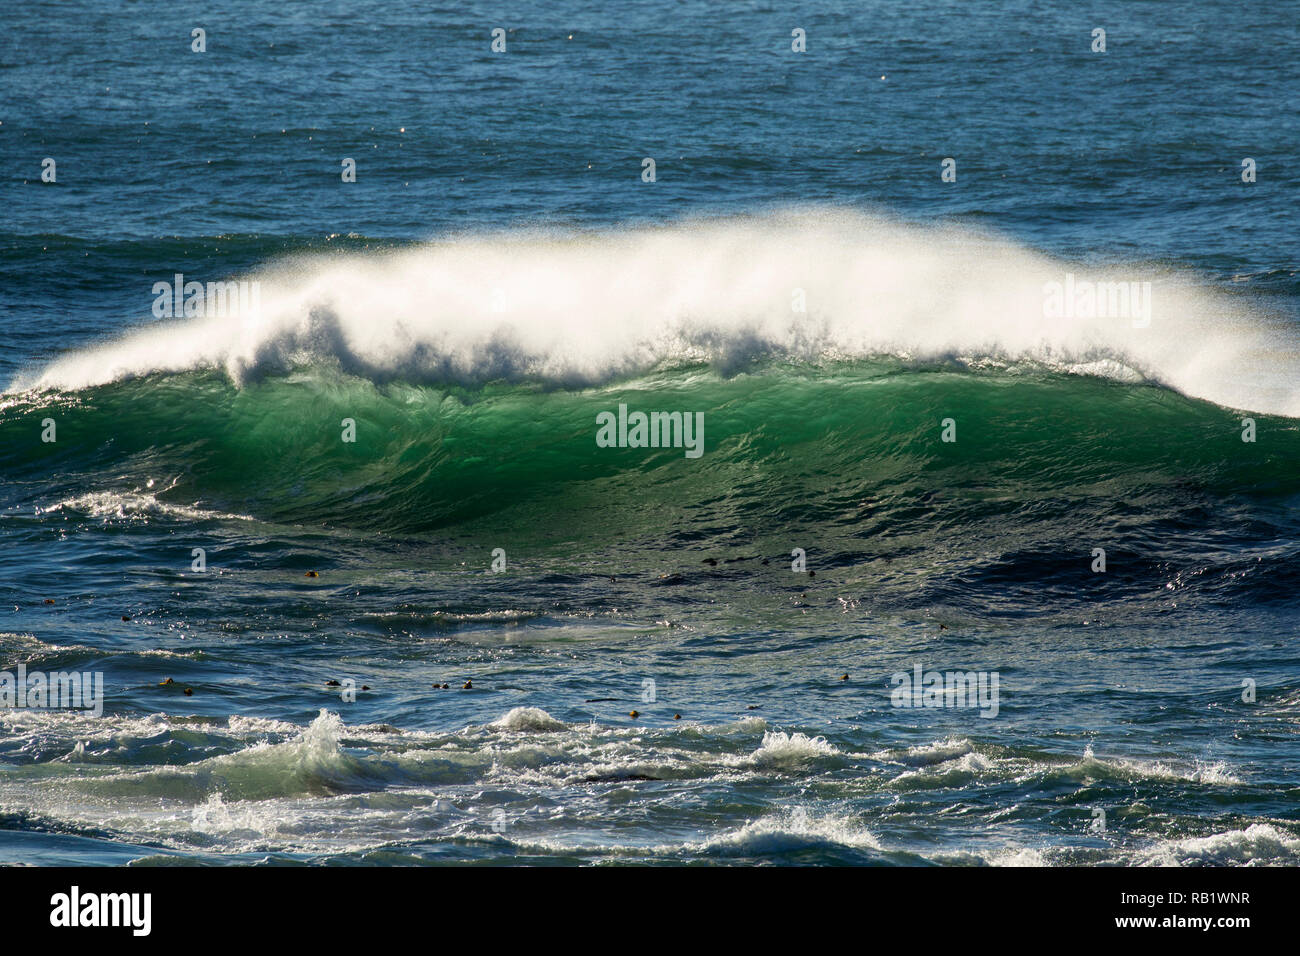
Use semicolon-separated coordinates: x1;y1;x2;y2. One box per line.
0;0;1300;865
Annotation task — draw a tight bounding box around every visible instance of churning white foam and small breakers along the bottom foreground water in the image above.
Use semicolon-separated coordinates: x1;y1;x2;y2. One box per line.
0;708;1300;865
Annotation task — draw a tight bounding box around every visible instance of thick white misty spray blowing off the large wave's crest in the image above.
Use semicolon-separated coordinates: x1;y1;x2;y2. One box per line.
10;209;1300;416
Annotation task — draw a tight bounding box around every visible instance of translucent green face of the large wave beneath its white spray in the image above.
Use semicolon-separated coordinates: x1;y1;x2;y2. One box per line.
0;362;1300;544
